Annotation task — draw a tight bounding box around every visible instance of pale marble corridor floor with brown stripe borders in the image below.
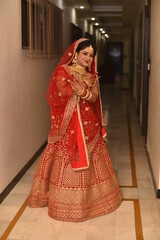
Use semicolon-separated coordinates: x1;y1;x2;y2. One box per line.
0;84;160;240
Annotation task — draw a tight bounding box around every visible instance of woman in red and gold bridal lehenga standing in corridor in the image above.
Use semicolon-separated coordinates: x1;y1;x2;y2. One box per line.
28;38;122;222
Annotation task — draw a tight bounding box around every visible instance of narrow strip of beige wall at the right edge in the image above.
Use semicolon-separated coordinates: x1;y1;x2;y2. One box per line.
147;0;160;189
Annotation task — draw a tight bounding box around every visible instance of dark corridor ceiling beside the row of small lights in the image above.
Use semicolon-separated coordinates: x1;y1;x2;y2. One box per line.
65;0;142;37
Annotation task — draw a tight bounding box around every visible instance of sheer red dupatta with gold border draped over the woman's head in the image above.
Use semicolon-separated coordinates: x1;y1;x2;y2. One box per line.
47;38;106;170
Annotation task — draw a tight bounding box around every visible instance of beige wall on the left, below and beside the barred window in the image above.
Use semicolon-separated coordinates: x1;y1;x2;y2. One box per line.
0;0;58;192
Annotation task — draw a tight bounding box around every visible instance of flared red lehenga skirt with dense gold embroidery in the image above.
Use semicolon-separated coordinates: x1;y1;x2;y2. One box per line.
28;134;122;222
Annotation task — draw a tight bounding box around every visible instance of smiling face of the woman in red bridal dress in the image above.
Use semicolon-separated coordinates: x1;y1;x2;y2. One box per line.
77;46;94;67
